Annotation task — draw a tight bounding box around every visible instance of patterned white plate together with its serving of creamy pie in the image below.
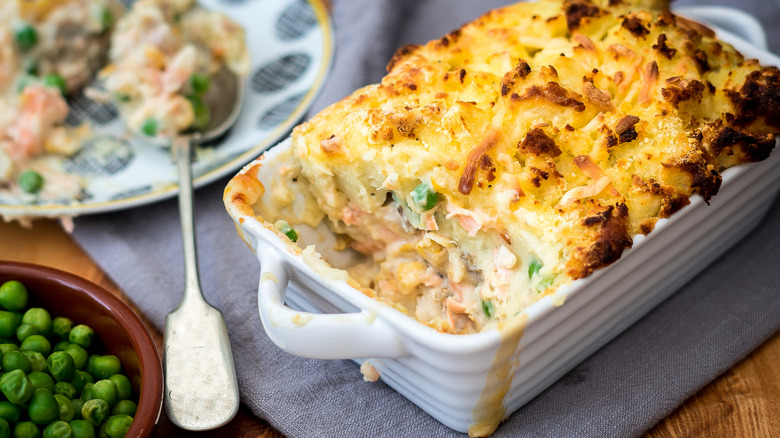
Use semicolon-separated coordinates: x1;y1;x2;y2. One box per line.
0;0;333;221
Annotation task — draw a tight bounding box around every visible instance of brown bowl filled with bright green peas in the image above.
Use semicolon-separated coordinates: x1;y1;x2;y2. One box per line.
0;261;163;438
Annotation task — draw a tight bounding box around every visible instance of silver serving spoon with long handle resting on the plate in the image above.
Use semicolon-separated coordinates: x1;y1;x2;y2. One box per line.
163;68;244;430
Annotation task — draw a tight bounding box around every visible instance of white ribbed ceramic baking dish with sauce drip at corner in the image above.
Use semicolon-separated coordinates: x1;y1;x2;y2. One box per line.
225;8;780;435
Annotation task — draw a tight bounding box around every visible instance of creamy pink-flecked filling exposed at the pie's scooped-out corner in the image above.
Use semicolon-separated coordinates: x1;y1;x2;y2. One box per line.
255;149;554;333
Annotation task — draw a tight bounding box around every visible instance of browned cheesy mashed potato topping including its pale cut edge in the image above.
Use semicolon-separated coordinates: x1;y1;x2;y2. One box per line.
293;0;780;327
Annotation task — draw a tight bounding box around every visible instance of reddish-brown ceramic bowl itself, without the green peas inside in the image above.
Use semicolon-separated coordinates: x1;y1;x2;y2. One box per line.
0;261;163;437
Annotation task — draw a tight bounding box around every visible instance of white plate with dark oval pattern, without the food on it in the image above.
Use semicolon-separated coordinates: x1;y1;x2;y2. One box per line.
0;0;333;219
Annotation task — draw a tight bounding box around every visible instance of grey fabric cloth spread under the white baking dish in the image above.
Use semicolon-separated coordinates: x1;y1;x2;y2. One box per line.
74;0;780;437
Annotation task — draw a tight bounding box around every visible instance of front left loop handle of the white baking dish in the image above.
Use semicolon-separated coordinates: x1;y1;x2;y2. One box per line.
257;248;404;359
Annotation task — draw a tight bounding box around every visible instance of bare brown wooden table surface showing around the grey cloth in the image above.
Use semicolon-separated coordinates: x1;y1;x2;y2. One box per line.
0;220;780;438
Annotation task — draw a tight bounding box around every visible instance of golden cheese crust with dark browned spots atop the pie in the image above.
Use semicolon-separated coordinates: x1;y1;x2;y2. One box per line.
296;0;780;278
